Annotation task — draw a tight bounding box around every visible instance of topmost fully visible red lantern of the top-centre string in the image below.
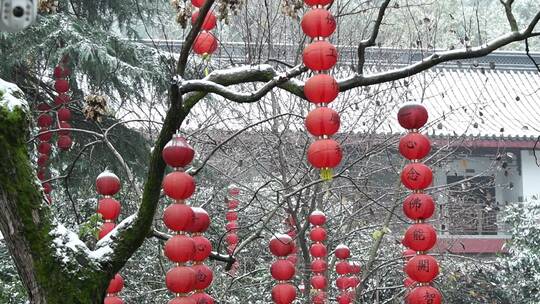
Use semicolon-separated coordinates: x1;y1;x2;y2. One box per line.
300;8;336;38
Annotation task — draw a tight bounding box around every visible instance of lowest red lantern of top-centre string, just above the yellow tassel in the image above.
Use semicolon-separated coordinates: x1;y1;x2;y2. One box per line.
307;139;343;169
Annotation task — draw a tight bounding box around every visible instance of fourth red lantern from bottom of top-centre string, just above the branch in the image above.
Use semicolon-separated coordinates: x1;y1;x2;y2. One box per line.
303;40;338;71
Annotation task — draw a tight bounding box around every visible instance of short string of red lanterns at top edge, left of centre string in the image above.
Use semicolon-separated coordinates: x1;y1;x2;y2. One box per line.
191;0;218;59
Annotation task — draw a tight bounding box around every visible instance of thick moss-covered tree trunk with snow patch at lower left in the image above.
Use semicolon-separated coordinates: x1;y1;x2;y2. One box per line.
0;105;112;304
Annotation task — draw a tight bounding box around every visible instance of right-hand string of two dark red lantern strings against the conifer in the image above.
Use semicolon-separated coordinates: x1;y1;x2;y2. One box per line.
53;59;73;151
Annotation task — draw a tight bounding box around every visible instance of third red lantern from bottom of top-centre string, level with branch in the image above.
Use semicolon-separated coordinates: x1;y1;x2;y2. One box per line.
304;74;339;104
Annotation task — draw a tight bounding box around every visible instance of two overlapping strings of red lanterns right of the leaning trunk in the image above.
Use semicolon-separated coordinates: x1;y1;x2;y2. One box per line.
162;134;213;304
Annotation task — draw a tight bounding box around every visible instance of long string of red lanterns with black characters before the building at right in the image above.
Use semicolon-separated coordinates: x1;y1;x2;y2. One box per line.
398;104;442;304
